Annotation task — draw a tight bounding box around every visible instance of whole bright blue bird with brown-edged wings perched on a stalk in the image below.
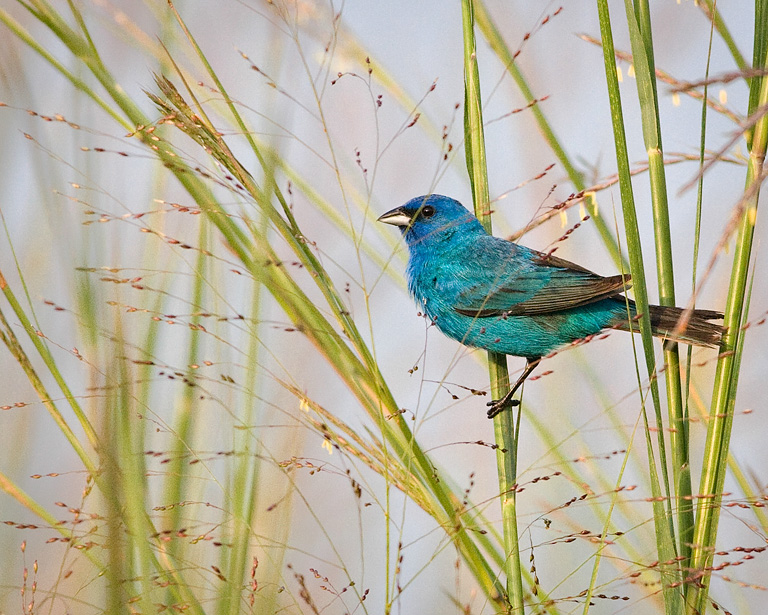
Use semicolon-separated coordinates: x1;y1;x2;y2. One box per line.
379;194;724;418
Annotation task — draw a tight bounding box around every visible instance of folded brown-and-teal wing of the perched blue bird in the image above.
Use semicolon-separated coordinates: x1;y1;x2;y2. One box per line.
454;246;631;318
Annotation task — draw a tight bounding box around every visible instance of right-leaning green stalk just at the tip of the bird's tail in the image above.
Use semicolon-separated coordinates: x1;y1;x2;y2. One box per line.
689;37;768;614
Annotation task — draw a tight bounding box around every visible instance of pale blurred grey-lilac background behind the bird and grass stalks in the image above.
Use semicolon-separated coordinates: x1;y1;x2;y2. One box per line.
0;0;768;613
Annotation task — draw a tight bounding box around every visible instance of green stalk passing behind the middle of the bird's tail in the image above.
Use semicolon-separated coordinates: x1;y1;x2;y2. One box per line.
624;0;693;568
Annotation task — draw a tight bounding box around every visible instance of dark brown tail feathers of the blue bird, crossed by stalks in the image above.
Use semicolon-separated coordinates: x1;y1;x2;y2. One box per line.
618;305;725;348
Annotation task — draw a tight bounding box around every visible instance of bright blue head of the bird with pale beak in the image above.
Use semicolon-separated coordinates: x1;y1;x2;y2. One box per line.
379;194;485;247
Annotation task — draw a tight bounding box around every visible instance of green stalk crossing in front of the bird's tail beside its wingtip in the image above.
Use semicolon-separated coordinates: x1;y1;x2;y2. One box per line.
585;0;683;615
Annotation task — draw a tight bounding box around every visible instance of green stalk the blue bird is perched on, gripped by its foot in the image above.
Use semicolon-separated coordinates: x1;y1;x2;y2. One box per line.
461;0;524;613
